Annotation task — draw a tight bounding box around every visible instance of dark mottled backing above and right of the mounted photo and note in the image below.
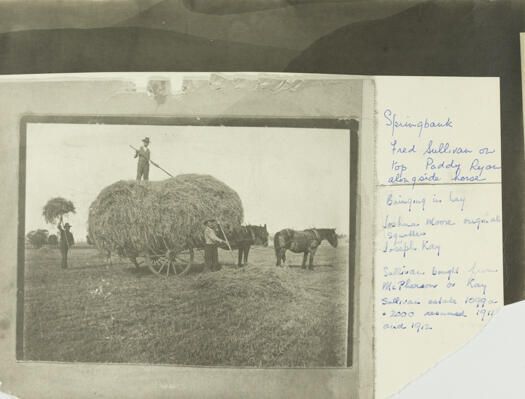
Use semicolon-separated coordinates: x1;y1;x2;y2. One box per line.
0;0;525;303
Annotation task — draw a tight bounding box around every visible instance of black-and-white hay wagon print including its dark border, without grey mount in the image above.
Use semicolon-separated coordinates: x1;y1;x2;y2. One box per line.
17;116;358;368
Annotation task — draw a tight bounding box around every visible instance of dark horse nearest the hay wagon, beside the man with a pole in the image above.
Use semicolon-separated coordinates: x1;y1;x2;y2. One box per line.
217;225;268;267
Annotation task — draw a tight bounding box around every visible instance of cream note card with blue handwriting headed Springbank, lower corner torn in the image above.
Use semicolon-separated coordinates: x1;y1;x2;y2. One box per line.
375;77;503;398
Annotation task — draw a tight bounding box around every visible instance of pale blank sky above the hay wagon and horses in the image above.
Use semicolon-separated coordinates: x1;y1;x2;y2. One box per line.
26;123;350;241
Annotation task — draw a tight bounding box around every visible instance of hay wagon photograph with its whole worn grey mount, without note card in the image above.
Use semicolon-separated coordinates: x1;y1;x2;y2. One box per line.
0;73;374;398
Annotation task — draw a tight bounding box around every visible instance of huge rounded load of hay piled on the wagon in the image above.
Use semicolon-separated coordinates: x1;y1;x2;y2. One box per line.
88;174;243;259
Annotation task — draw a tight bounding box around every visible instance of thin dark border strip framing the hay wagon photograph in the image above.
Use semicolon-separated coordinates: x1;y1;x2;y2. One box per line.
15;114;360;369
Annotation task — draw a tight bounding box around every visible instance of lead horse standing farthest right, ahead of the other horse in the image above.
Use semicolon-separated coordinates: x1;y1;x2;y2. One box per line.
273;229;337;270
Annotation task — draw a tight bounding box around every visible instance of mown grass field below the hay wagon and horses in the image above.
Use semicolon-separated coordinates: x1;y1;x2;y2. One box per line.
24;243;348;367
